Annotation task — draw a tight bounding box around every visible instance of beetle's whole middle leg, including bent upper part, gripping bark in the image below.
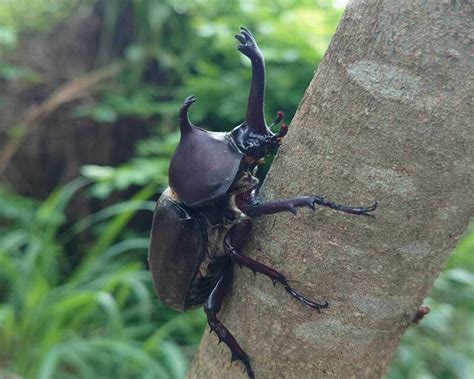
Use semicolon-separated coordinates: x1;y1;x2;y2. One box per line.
224;220;329;313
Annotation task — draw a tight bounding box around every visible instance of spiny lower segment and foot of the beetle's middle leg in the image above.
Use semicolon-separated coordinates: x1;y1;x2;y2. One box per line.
225;234;329;313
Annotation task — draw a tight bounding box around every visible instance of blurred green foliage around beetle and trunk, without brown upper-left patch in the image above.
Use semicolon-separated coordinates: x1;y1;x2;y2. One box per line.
0;0;474;379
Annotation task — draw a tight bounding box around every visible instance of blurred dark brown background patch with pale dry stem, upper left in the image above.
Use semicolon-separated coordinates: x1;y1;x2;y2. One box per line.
0;2;149;199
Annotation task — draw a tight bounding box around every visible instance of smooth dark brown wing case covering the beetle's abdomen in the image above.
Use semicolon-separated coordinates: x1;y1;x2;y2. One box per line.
148;188;206;311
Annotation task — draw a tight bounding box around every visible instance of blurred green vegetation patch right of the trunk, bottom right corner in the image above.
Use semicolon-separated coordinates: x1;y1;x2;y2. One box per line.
388;230;474;379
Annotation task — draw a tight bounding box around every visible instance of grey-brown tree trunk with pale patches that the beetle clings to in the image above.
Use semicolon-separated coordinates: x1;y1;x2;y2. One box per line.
190;0;474;378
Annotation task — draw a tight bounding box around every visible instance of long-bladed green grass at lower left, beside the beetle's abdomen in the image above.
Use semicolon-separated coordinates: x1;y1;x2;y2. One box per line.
0;183;204;379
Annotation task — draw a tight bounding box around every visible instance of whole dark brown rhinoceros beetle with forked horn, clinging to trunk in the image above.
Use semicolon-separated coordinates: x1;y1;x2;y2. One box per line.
148;27;377;378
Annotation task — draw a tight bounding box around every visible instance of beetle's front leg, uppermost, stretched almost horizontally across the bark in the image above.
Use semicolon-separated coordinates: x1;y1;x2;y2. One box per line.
238;196;377;217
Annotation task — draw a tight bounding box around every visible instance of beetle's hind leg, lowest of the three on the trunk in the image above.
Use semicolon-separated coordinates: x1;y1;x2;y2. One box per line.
204;265;255;379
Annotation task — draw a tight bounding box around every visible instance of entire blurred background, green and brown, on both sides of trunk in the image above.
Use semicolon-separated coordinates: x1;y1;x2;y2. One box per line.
0;0;474;379
